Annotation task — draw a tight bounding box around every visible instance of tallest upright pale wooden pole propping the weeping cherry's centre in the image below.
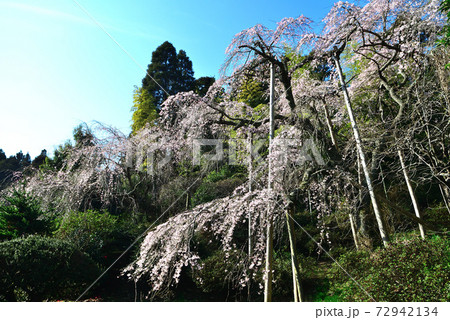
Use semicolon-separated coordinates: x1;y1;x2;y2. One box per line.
264;64;274;302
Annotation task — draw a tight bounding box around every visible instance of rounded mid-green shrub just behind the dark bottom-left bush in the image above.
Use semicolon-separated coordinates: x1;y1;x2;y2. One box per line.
55;210;119;259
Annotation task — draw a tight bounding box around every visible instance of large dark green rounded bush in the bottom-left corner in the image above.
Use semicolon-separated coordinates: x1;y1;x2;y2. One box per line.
0;236;99;301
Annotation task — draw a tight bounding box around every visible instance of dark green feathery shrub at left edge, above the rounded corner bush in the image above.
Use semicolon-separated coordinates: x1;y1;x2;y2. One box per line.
0;190;53;240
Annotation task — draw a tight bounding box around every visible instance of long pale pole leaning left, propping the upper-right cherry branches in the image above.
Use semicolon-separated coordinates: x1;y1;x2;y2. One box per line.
333;56;389;247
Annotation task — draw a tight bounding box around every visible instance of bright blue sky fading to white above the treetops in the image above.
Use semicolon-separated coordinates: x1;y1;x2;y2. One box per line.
0;0;335;158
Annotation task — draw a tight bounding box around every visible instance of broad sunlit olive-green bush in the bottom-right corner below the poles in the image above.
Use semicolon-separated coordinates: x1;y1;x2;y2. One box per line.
331;237;450;302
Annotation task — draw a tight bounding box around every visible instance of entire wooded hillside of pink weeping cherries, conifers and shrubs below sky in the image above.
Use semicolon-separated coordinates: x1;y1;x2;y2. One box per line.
0;0;450;301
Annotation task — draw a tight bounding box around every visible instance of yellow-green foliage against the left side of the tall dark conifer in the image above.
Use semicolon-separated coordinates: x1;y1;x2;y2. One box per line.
131;87;158;134
